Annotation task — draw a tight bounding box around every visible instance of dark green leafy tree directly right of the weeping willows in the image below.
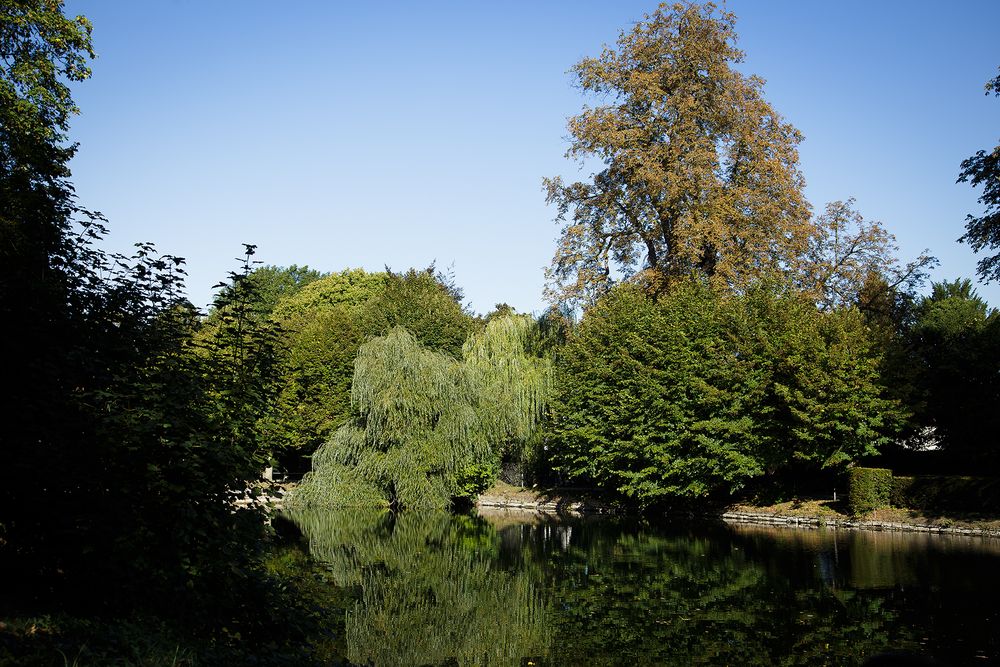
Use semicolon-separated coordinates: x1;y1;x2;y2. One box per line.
547;284;763;505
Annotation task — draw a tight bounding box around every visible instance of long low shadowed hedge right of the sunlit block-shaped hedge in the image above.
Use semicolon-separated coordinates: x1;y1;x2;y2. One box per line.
890;475;1000;514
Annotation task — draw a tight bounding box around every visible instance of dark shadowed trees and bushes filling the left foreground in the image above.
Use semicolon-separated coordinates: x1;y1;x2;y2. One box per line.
0;6;316;664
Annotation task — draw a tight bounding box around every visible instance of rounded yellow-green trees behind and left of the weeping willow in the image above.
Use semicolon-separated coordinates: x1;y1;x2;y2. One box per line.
255;267;475;470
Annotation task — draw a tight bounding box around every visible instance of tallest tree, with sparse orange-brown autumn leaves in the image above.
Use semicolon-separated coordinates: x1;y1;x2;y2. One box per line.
545;4;810;302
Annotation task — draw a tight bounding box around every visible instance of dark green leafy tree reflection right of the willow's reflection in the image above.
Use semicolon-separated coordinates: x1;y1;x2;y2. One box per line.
536;527;914;665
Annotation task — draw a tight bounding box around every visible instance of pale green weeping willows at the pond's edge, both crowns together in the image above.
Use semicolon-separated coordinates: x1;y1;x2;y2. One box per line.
290;315;551;508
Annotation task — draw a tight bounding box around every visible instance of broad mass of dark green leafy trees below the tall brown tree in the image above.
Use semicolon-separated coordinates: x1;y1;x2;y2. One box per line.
549;282;897;503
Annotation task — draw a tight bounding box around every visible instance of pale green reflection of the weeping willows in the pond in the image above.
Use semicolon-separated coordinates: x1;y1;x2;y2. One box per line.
293;510;552;667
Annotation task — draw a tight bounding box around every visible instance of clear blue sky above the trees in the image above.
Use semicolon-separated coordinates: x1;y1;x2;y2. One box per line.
66;0;1000;312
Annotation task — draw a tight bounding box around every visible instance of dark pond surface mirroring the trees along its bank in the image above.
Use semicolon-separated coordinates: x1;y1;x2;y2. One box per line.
282;510;1000;665
